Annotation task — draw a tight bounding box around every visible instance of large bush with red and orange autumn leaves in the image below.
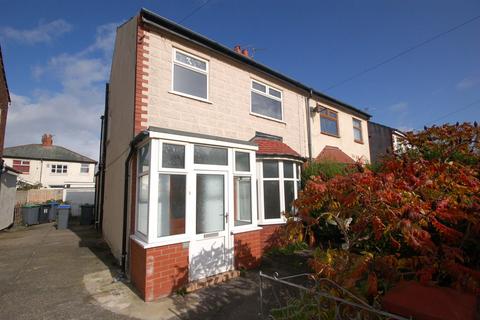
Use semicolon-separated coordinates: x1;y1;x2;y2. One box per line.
287;123;480;300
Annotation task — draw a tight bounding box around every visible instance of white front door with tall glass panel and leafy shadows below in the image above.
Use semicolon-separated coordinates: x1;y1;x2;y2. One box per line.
189;171;233;281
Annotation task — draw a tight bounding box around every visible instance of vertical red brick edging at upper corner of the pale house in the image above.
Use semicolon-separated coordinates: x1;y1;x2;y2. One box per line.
134;21;149;135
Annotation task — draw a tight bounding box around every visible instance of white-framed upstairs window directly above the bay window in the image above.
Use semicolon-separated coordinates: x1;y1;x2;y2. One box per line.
251;80;283;120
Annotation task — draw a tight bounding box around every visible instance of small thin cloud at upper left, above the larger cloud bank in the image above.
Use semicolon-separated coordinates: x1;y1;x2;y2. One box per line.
0;19;72;45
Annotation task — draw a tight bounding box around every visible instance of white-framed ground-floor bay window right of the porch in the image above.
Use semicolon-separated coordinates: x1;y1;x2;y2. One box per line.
257;158;300;224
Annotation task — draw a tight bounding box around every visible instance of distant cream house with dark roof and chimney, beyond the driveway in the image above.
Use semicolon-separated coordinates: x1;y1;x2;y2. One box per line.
3;134;96;188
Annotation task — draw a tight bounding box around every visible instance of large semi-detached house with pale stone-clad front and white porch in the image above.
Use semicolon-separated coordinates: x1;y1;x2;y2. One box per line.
98;9;370;301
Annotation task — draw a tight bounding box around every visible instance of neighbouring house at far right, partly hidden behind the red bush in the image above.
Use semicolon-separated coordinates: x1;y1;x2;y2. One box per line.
368;121;405;163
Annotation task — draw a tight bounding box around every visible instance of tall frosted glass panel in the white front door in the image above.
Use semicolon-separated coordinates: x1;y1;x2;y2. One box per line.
196;174;225;234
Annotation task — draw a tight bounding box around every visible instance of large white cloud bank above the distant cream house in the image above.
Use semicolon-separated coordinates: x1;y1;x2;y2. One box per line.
7;24;119;159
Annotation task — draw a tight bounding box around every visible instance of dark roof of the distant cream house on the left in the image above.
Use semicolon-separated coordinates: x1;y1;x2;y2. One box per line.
3;144;97;163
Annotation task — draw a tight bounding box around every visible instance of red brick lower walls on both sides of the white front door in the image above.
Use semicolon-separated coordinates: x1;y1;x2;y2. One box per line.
130;225;280;301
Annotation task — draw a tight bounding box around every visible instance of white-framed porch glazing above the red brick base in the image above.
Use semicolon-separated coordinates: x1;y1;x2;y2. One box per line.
131;134;258;246
